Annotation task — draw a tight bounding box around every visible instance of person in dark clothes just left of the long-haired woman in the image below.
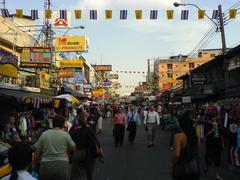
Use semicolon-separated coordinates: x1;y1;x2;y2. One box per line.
167;109;179;150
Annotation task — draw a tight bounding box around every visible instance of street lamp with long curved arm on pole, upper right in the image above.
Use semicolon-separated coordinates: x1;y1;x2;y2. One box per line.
173;2;227;54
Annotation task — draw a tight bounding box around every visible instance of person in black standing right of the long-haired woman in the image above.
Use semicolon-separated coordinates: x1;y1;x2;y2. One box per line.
204;113;224;180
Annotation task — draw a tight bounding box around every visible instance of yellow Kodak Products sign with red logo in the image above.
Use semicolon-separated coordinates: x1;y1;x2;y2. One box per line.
55;36;89;52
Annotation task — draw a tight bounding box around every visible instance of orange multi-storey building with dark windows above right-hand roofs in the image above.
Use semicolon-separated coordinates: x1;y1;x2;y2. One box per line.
154;49;221;92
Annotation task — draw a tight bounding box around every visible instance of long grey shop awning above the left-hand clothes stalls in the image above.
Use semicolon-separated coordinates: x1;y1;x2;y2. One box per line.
0;88;52;99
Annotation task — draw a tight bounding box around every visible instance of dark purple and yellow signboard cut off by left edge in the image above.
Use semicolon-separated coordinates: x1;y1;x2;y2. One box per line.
0;49;18;78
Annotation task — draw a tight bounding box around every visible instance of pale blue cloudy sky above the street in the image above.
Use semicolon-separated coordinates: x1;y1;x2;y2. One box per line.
6;0;240;93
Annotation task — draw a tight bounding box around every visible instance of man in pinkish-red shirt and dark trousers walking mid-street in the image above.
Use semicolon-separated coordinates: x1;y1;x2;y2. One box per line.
113;108;127;147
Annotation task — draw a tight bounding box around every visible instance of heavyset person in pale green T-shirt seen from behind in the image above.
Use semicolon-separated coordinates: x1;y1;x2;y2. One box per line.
34;115;75;180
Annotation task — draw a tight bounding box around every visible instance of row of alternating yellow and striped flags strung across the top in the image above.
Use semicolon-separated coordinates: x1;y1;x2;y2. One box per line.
1;9;239;20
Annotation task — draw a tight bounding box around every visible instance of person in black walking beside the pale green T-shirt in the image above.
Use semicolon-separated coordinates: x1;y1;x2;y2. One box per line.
71;118;103;180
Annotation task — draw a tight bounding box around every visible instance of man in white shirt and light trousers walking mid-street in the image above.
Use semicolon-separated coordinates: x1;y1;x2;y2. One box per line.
144;106;160;148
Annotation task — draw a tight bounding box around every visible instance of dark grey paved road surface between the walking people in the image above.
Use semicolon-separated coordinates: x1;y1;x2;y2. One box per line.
95;121;240;180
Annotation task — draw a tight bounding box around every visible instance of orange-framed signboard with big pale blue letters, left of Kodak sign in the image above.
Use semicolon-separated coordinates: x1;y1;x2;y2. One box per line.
20;47;51;68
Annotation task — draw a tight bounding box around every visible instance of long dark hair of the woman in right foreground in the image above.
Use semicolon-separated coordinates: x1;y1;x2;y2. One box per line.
178;111;198;148
